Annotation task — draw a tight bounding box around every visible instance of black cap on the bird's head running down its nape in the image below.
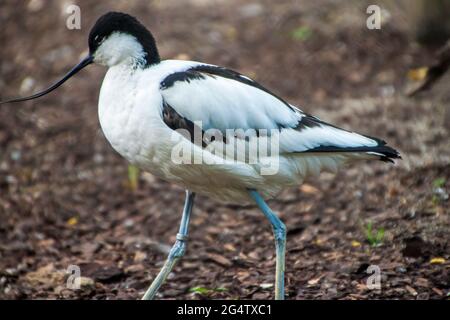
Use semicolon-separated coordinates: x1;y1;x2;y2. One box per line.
89;12;160;65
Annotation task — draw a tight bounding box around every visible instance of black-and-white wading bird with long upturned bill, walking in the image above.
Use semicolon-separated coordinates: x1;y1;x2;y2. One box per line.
3;12;400;299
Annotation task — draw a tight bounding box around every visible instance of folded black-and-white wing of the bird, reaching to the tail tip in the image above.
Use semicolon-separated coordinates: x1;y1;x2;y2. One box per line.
160;64;399;161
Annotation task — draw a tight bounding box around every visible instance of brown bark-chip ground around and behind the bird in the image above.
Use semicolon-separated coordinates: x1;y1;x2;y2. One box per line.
0;0;450;299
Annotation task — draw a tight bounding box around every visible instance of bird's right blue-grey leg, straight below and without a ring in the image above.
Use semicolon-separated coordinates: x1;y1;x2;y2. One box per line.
249;190;286;300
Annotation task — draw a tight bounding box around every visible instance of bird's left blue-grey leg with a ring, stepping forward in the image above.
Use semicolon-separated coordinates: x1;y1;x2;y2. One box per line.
142;190;195;300
